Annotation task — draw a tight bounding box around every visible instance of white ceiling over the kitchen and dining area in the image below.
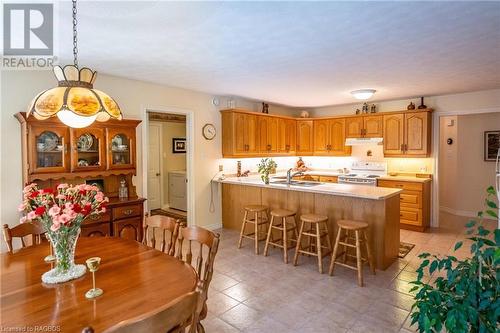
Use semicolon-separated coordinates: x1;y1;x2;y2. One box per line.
58;1;500;106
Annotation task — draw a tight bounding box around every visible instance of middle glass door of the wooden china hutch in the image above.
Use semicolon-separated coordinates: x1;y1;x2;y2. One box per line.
71;128;105;170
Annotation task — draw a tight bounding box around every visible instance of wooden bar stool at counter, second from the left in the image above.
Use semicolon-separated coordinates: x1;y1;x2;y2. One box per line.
264;209;297;264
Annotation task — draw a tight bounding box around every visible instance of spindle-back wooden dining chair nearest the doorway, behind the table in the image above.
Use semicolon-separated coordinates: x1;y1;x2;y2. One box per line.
142;213;182;256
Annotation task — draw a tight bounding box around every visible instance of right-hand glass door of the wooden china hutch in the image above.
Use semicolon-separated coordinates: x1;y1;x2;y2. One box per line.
107;128;135;169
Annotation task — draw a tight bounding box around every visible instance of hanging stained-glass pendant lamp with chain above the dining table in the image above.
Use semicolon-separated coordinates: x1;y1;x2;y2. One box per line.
27;0;122;128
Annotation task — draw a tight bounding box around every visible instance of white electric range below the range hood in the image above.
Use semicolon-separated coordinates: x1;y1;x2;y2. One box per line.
338;161;387;186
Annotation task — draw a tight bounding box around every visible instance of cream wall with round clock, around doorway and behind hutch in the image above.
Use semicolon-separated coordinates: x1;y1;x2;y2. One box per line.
0;71;296;246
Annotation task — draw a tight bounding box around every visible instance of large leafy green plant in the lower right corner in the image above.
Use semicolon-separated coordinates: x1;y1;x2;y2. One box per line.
411;187;500;333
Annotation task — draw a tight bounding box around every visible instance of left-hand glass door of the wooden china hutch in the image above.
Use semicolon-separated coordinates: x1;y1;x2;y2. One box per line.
29;126;68;173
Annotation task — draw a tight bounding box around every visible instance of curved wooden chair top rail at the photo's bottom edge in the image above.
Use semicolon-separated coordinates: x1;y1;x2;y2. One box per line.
104;291;199;333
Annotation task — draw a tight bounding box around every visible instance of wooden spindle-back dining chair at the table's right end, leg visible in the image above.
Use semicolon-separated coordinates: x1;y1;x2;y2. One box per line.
176;226;220;333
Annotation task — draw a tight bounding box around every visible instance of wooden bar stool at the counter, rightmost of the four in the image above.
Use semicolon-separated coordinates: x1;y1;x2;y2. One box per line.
329;220;375;287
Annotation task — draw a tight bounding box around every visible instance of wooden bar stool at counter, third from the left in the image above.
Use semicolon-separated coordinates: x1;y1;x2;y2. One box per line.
293;214;332;274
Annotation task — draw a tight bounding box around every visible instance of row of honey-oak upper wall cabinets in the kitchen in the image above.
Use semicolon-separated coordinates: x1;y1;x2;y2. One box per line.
220;108;433;158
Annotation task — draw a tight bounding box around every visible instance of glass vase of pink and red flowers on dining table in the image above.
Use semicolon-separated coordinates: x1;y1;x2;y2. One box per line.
19;184;109;283
